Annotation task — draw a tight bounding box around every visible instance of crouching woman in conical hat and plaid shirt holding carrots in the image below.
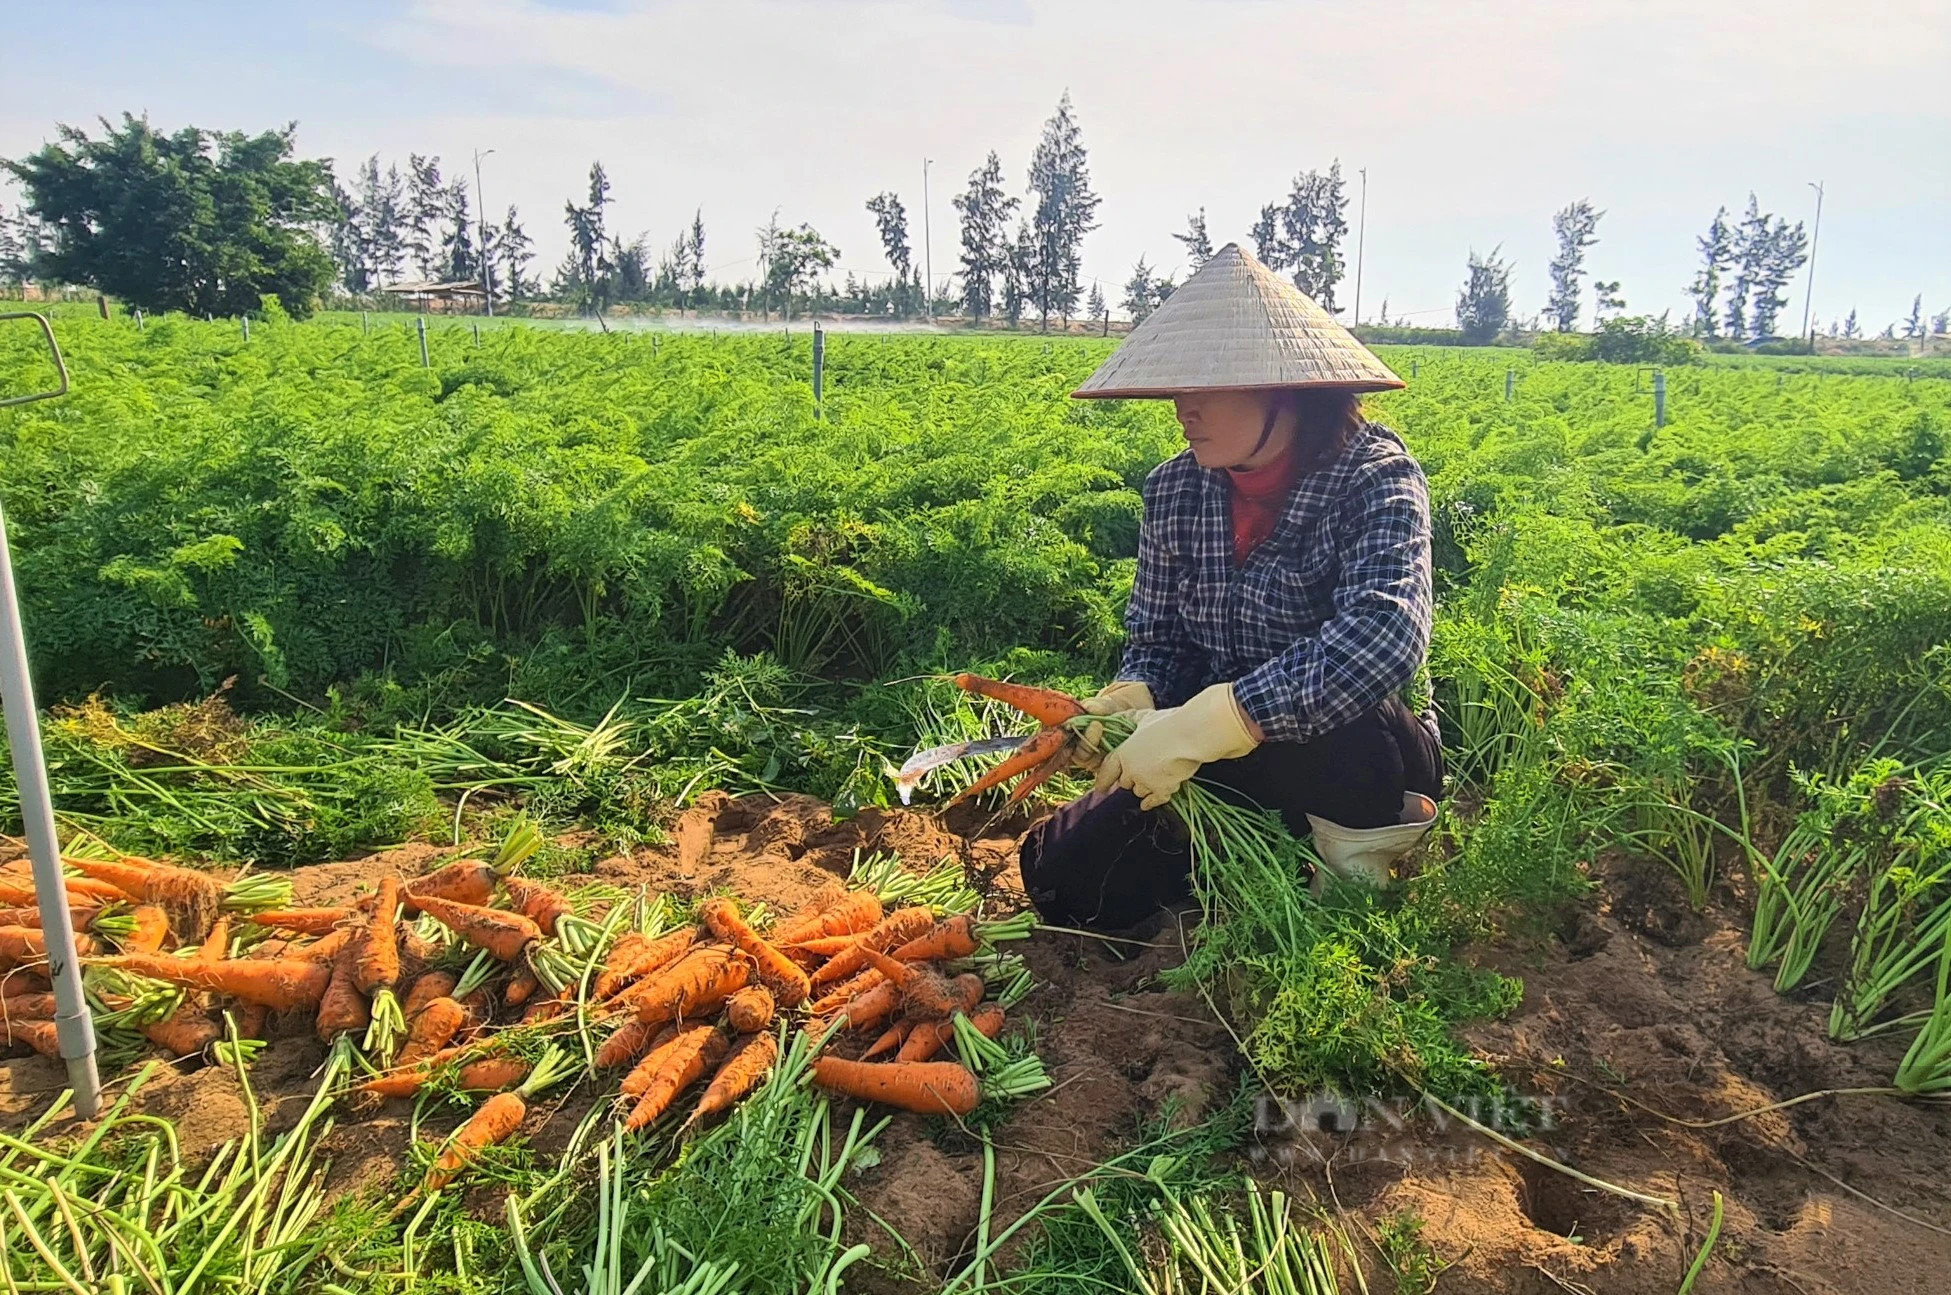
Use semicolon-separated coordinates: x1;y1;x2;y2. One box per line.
1020;244;1442;926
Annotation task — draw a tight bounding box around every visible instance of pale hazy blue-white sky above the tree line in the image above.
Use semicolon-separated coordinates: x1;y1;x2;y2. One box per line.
0;0;1951;334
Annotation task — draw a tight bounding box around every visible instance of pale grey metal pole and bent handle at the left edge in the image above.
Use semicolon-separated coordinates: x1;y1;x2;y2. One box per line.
0;312;101;1119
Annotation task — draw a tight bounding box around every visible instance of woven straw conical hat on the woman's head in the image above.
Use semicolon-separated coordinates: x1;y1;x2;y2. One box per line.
1071;244;1405;400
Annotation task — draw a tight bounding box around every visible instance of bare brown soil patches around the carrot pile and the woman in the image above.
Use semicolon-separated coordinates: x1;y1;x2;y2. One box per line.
0;796;1951;1295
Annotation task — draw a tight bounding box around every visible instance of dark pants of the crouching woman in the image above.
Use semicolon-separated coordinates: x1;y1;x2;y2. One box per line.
1018;698;1444;930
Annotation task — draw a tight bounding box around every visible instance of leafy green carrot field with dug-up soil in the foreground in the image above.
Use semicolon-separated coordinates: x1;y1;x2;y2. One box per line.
0;310;1951;1295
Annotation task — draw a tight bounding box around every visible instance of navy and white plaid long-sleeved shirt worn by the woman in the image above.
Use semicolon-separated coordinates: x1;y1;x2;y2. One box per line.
1118;423;1432;741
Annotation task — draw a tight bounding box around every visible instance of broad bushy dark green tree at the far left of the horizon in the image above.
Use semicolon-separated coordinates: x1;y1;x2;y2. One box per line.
0;113;338;316
